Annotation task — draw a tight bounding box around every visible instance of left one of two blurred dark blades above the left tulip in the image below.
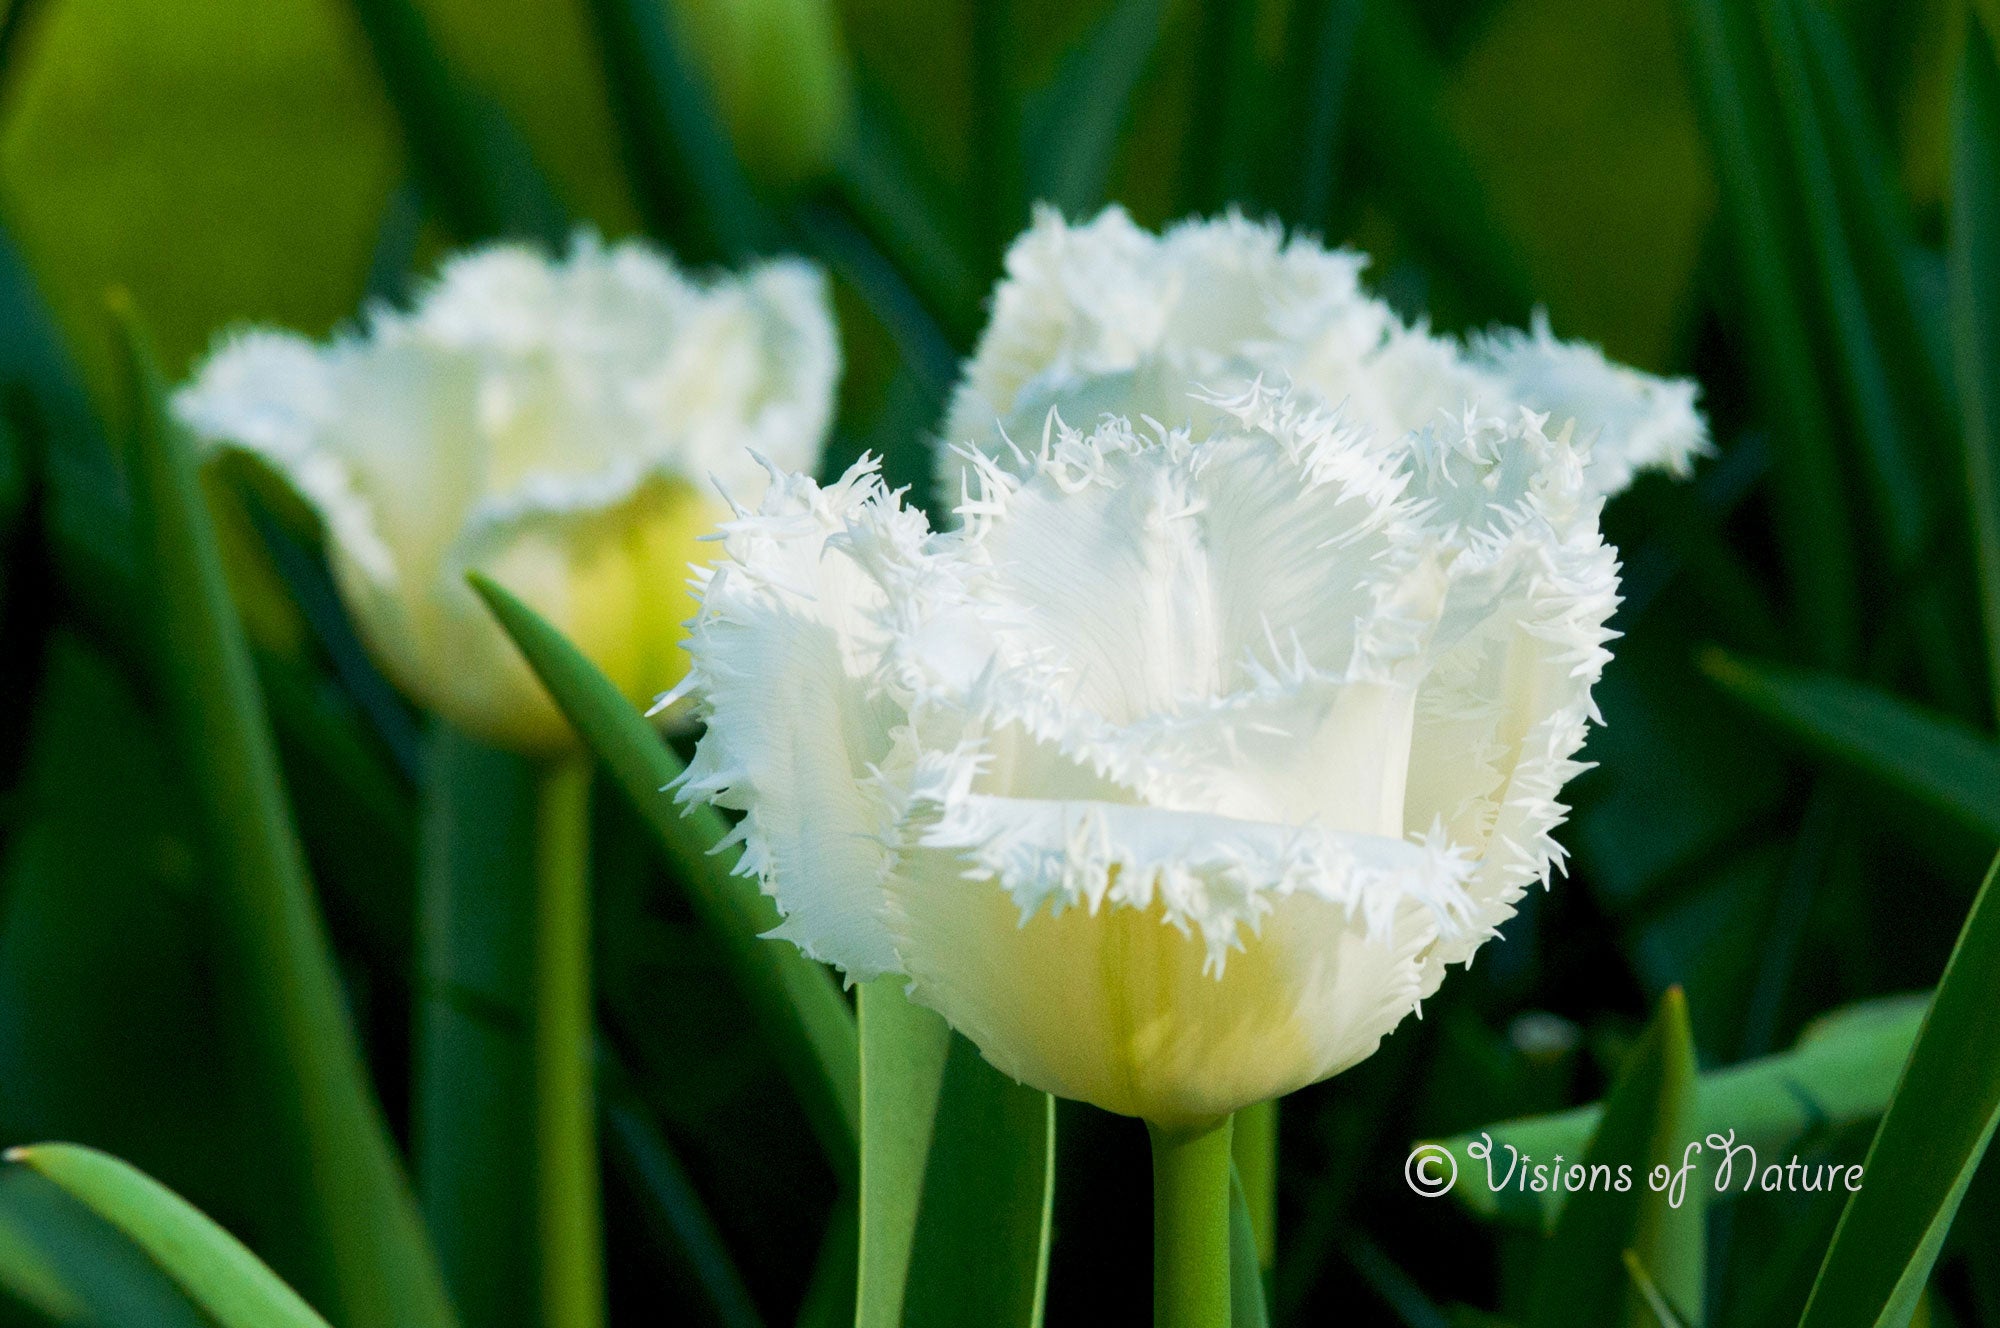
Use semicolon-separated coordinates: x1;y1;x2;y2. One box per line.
350;0;570;244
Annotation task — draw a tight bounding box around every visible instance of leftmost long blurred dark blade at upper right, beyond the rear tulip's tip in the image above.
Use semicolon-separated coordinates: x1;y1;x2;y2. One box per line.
1684;0;1860;666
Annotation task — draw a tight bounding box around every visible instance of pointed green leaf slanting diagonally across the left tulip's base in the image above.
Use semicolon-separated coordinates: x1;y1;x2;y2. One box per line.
470;574;860;1178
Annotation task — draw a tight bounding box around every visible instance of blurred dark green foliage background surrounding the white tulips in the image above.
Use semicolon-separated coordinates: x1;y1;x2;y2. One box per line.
0;0;2000;1328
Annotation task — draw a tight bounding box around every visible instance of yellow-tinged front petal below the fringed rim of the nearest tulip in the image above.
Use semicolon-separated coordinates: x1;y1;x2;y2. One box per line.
892;850;1456;1128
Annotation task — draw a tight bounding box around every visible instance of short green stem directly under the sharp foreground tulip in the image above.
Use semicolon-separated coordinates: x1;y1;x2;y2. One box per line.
1146;1116;1230;1328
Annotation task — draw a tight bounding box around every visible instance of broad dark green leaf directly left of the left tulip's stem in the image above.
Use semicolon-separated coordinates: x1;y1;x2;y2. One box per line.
410;724;536;1328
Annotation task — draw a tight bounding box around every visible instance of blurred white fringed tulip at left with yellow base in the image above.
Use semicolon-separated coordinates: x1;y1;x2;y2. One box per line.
174;238;840;748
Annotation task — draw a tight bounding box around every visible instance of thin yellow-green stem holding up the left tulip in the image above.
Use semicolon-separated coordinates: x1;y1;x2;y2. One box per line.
534;758;604;1328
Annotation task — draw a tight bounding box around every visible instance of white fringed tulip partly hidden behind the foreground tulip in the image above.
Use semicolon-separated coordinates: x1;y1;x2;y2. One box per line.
940;208;1708;508
